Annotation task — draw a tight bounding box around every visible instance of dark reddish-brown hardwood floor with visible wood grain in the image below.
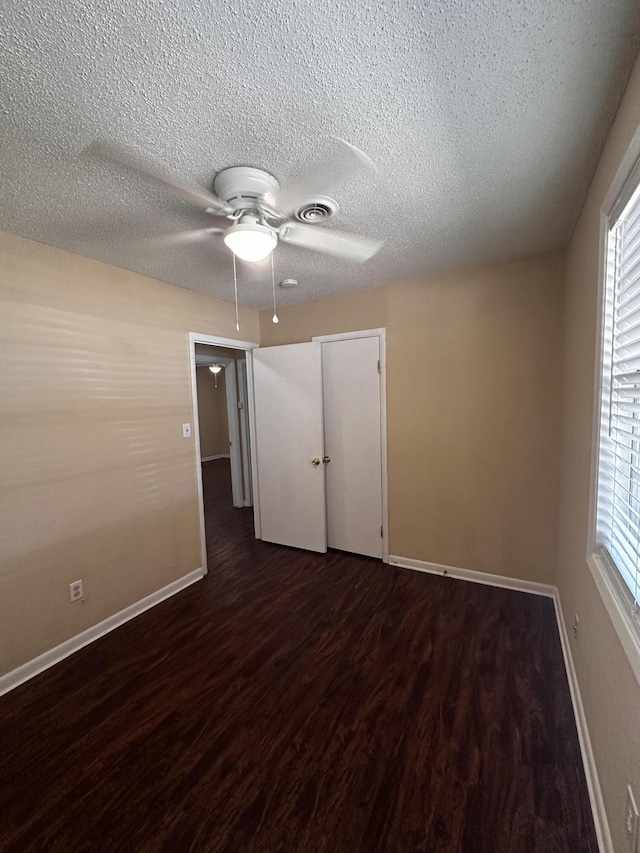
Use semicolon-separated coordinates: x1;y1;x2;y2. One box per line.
0;462;597;853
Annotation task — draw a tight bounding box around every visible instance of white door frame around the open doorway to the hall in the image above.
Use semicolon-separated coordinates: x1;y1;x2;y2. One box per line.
189;332;260;574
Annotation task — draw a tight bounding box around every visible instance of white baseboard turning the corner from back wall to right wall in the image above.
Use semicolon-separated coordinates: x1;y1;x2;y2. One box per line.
389;556;615;853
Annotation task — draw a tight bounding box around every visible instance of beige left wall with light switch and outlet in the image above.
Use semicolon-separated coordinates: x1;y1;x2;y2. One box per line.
0;233;259;673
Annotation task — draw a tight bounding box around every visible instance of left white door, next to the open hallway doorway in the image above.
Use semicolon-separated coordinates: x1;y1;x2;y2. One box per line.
253;342;327;552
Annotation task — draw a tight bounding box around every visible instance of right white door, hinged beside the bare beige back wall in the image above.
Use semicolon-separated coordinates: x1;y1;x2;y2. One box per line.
321;337;382;557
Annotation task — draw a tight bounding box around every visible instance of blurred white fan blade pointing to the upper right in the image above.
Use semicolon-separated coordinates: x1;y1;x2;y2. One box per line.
265;139;376;213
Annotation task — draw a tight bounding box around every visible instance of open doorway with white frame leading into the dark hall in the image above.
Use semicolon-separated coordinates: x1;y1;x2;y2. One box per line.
189;333;257;572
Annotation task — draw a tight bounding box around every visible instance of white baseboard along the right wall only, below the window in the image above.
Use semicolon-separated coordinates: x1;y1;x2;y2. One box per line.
553;589;615;853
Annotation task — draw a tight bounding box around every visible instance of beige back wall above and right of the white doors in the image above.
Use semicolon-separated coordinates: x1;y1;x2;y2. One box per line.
260;252;565;582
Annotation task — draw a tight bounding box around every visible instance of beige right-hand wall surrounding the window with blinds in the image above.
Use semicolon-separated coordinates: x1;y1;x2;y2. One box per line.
558;58;640;851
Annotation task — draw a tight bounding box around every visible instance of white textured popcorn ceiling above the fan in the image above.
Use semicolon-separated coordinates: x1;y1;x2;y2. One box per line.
0;0;640;307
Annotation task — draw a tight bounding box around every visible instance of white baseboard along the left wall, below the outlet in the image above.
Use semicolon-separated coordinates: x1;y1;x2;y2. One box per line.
0;568;204;696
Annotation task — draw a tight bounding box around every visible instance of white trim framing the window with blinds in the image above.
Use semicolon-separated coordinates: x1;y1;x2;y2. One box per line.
586;127;640;685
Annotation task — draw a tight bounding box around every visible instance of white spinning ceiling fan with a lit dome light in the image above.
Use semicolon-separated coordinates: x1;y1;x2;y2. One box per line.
89;140;382;263
